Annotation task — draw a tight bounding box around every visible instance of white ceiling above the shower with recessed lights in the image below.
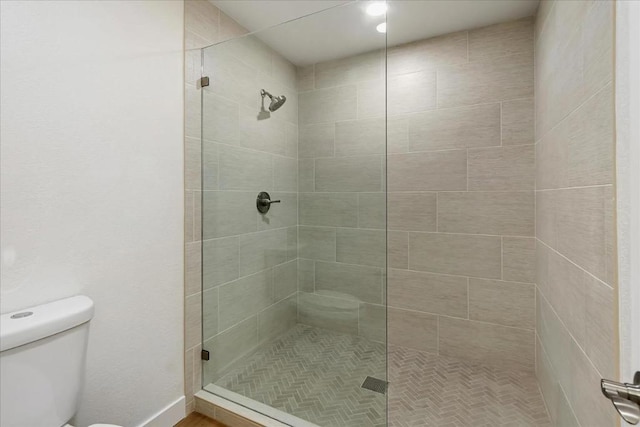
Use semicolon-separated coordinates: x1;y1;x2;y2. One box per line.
210;0;539;65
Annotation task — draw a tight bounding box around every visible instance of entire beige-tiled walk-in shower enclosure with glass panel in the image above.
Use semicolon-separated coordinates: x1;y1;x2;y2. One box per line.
186;0;617;427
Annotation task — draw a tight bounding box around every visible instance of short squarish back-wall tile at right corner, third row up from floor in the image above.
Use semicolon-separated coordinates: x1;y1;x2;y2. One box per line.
502;236;536;283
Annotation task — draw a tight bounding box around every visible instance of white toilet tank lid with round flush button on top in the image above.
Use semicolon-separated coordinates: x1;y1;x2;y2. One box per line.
0;295;93;351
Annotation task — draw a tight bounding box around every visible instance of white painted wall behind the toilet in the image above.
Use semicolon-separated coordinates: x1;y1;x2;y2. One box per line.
0;0;184;426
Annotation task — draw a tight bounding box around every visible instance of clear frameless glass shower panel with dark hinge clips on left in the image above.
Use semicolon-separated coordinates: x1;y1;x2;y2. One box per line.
201;3;387;427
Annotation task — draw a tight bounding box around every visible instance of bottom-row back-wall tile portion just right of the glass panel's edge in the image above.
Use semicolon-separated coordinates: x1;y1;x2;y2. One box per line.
387;307;438;353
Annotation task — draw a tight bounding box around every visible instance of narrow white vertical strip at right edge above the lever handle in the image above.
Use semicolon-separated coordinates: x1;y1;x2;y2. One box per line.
616;1;640;388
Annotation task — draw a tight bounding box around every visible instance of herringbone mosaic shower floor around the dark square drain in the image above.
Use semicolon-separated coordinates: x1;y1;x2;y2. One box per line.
210;325;550;427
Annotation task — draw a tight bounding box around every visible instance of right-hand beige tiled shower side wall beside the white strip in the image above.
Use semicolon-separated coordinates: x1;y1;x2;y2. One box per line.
535;1;617;426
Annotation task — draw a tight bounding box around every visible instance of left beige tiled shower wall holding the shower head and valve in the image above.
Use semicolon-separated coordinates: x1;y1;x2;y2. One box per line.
185;0;298;411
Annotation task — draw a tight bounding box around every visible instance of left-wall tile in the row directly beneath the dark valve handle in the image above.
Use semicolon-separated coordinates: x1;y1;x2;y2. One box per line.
240;229;287;277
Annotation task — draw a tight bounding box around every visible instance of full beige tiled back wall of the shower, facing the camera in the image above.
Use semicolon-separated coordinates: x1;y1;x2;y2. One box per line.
298;19;535;370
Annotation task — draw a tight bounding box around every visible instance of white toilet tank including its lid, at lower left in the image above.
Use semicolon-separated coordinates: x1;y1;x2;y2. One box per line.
0;296;93;427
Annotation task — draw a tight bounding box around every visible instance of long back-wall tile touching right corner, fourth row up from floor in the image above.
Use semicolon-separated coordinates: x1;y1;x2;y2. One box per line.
438;191;535;236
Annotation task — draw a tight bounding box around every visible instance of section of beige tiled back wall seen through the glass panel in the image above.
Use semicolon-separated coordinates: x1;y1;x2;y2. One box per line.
298;46;386;341
